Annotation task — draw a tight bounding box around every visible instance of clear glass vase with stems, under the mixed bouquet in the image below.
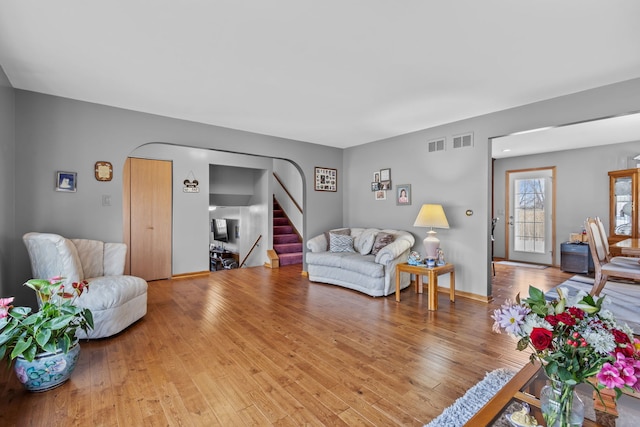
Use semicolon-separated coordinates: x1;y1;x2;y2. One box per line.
540;380;584;427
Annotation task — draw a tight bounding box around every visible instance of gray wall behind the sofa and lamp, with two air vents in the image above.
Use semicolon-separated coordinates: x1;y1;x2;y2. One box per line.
343;79;640;296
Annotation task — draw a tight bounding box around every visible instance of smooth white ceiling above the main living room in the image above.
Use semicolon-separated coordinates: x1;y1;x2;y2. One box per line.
0;0;640;147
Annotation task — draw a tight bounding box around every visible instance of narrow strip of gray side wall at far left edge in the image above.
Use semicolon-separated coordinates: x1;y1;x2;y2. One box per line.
0;67;18;297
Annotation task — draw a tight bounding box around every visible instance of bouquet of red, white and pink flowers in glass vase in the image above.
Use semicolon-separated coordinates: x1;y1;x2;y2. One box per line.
491;286;640;424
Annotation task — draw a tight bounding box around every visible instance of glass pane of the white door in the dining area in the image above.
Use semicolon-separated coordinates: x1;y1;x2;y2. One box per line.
513;178;545;253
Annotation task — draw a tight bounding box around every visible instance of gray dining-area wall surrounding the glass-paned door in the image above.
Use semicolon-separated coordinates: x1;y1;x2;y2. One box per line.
493;141;640;265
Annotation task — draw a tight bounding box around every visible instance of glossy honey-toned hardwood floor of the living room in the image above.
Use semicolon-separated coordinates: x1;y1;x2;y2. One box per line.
0;265;572;426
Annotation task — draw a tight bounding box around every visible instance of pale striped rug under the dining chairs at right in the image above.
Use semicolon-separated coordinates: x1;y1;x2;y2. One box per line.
545;275;640;335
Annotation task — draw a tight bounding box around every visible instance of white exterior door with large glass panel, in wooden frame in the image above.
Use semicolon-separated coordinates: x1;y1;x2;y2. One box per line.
506;168;554;265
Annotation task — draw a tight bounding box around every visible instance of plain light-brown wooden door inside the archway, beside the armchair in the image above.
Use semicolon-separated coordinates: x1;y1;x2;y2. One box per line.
124;158;173;280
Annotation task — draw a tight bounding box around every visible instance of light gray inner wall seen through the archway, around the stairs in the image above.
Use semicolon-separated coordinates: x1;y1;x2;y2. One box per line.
129;142;306;276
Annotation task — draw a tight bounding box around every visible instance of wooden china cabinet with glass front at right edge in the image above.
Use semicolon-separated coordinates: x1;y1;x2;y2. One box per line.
609;169;640;244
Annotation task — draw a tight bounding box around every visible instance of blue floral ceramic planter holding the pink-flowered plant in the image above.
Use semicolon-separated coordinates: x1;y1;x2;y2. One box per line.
13;341;80;391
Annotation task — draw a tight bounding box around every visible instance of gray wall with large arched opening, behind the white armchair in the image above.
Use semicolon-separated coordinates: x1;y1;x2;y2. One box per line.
13;90;343;304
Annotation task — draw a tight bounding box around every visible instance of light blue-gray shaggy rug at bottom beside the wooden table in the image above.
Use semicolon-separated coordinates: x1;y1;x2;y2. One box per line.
425;369;515;427
